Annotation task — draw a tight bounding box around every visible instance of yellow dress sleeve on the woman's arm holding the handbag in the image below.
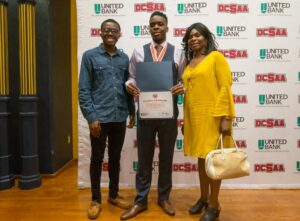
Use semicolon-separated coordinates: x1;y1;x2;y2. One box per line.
213;52;235;118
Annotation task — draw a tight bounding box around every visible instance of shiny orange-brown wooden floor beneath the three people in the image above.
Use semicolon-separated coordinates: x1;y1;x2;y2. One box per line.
0;162;300;221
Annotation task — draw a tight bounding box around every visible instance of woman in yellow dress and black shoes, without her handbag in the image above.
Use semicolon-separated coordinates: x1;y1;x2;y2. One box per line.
182;23;235;221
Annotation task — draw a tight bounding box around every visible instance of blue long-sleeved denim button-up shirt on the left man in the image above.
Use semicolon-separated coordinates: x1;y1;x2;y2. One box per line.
78;45;135;123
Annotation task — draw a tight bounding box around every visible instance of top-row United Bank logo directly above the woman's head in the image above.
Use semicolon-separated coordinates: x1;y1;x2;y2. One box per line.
177;2;207;15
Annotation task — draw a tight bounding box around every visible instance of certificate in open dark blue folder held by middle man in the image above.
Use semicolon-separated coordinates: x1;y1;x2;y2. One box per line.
136;61;174;119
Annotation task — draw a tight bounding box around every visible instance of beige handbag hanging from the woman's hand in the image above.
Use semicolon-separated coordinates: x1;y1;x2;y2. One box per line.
205;134;250;180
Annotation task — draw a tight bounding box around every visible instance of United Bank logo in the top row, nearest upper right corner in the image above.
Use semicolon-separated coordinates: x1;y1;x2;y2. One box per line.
260;2;291;15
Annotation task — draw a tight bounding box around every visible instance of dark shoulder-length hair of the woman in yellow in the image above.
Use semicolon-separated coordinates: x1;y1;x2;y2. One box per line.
182;22;218;63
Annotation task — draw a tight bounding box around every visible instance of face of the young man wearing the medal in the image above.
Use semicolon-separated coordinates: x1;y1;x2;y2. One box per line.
149;15;168;44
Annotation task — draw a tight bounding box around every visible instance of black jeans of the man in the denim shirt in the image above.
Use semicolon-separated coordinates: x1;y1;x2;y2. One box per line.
90;122;126;203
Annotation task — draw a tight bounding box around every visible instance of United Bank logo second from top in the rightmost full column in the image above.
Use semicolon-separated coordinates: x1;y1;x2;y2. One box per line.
259;48;290;61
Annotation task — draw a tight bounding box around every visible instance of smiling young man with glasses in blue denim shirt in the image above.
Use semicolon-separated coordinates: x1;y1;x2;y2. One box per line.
79;19;135;219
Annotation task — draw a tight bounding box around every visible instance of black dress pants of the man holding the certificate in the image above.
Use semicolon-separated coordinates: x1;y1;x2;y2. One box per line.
135;119;178;205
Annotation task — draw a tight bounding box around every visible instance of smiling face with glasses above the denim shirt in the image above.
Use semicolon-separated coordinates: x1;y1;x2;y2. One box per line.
101;22;121;47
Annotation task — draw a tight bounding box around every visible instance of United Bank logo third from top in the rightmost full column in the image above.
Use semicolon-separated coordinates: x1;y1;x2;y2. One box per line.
258;94;288;107
